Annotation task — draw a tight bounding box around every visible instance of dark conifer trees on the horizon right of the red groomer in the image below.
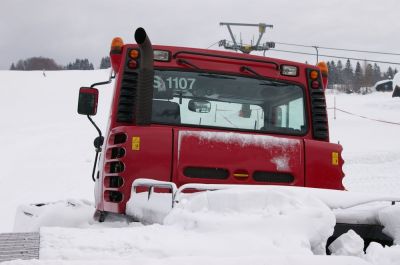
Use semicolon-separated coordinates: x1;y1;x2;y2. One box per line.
327;59;398;93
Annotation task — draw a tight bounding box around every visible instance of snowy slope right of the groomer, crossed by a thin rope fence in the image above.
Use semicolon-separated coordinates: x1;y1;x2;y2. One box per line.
327;91;400;194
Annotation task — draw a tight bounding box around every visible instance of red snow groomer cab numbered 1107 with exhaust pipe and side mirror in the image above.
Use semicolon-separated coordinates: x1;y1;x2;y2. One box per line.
78;28;343;220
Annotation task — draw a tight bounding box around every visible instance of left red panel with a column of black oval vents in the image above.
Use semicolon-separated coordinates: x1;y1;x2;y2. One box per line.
103;126;173;213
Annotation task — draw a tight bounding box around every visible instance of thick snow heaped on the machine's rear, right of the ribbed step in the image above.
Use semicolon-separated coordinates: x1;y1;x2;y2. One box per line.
40;190;335;264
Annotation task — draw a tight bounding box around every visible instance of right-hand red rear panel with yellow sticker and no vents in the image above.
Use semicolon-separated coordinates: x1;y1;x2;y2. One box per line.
304;140;344;190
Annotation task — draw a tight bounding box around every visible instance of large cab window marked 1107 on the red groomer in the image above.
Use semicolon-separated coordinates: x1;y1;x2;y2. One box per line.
152;70;306;134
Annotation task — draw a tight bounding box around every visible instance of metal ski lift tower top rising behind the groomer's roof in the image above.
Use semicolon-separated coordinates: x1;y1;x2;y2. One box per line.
219;22;275;53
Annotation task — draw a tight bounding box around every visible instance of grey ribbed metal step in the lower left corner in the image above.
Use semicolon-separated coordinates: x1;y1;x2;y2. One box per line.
0;232;40;262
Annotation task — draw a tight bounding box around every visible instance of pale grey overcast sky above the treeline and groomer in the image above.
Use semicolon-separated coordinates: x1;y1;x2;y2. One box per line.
0;0;400;69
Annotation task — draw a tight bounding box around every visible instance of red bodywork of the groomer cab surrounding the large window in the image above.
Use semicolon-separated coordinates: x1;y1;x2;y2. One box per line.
96;44;343;213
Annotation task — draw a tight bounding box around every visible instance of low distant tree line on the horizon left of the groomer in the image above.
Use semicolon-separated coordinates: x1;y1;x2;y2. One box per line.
10;56;111;71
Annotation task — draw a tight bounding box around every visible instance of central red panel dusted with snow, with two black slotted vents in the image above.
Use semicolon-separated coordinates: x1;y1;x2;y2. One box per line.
173;129;304;186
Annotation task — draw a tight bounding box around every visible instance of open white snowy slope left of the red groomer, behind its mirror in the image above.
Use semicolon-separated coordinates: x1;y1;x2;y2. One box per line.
0;70;112;232
